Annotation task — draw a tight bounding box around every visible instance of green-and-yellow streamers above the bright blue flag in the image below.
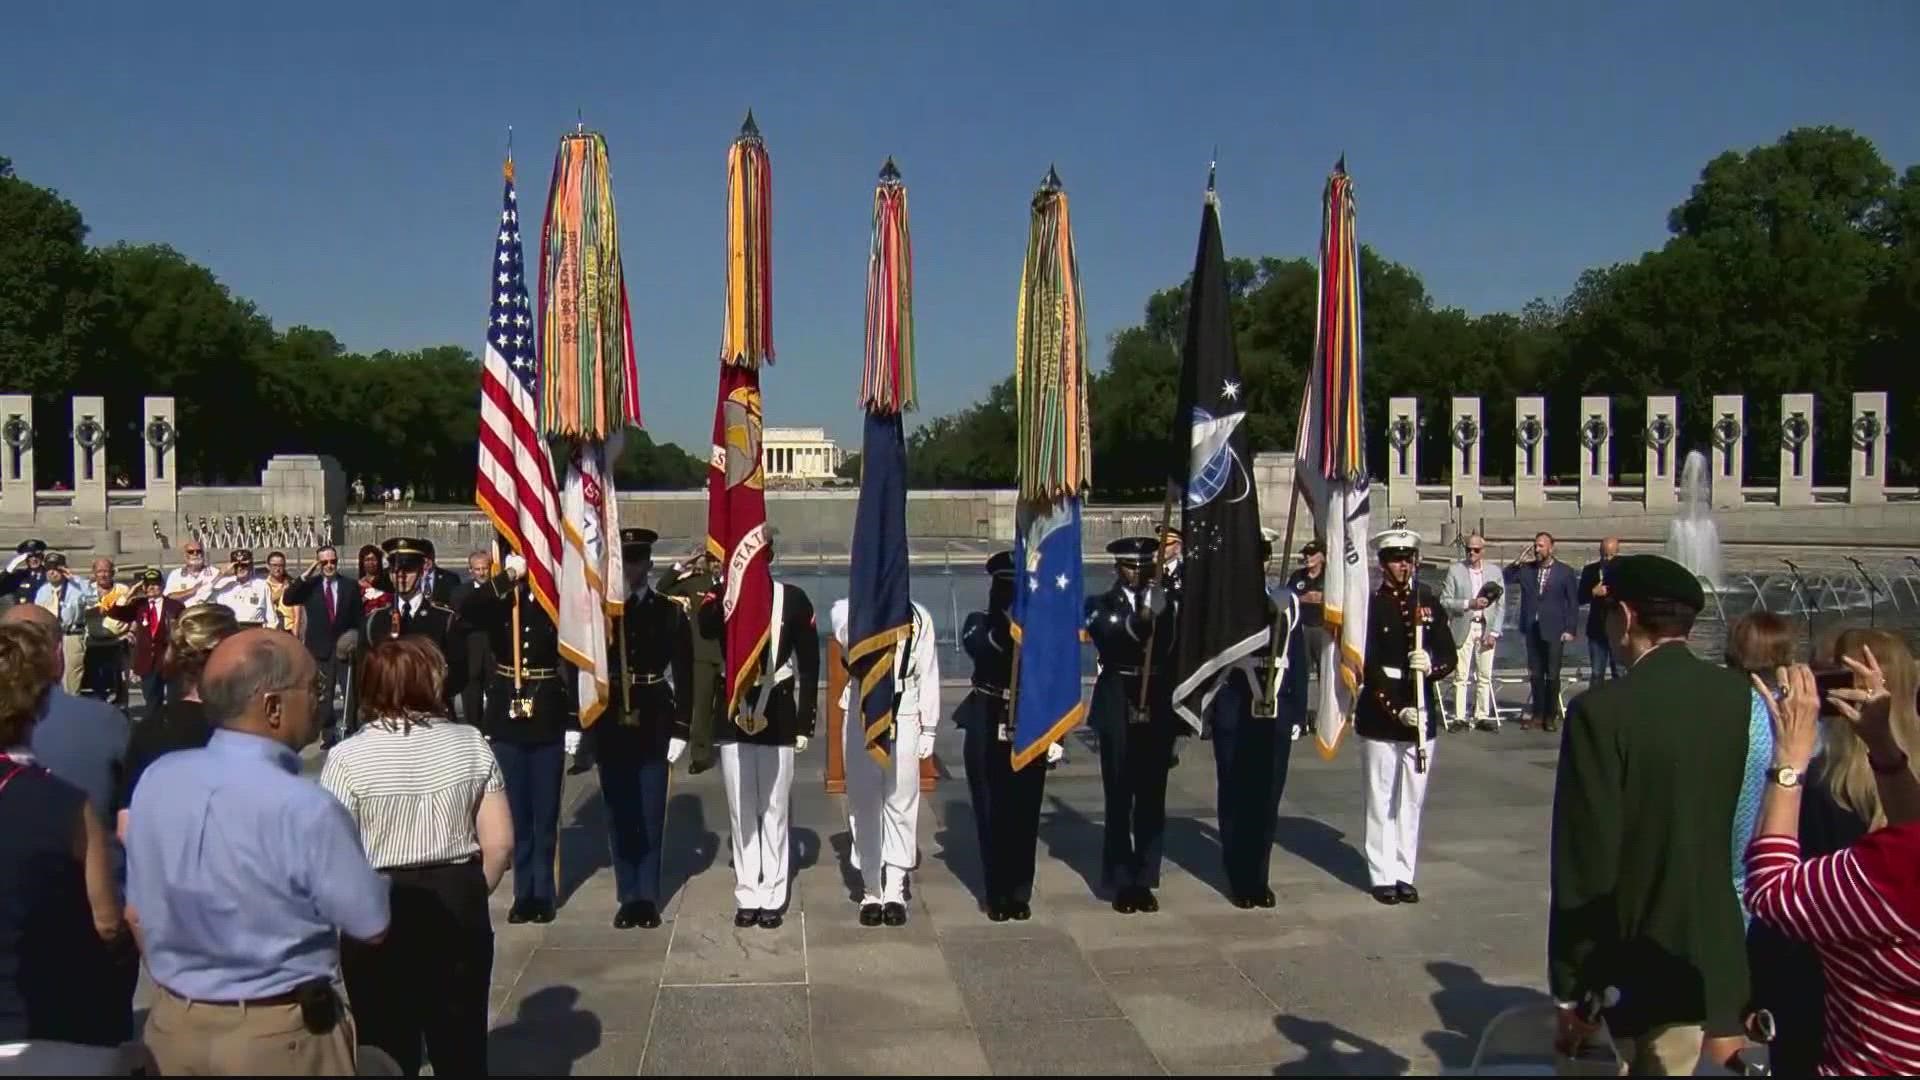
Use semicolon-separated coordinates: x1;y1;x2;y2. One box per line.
1014;169;1092;502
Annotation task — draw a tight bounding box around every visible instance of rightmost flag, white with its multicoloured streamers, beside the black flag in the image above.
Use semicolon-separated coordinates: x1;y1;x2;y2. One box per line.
1294;158;1371;757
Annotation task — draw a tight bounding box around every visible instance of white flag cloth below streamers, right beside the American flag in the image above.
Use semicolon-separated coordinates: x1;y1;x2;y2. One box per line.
555;436;626;728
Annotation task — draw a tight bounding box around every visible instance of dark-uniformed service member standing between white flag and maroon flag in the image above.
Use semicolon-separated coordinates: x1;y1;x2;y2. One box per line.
593;528;693;930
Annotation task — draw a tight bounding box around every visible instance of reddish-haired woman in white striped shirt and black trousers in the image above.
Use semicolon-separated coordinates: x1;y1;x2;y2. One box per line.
321;636;513;1076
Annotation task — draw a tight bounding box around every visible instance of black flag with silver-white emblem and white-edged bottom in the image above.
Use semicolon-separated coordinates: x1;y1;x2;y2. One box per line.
1167;190;1269;732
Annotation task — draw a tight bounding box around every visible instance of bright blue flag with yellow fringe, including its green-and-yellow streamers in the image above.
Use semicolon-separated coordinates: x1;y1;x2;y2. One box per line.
1010;169;1092;769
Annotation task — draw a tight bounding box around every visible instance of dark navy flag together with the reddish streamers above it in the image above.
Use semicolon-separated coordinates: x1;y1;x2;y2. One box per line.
847;158;914;765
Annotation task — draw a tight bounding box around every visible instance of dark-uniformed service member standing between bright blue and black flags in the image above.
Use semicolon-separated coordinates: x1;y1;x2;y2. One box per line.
1087;536;1185;915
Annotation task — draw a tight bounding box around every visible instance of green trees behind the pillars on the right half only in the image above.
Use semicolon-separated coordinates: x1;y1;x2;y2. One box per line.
908;127;1920;500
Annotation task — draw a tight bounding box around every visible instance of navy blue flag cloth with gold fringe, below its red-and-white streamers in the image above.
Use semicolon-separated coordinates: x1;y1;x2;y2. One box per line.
847;413;914;765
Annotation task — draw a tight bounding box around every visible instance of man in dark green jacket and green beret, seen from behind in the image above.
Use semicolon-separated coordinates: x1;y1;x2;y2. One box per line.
1548;555;1753;1076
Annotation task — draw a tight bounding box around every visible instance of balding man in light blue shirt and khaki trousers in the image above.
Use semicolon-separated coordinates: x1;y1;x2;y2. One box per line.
127;628;388;1076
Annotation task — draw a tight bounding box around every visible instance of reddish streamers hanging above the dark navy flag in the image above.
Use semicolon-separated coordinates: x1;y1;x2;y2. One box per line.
860;158;914;413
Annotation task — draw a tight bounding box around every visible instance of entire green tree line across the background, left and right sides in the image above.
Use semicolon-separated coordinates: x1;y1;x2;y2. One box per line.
0;127;1920;502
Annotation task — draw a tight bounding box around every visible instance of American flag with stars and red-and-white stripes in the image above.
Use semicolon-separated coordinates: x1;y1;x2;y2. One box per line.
474;158;561;619
